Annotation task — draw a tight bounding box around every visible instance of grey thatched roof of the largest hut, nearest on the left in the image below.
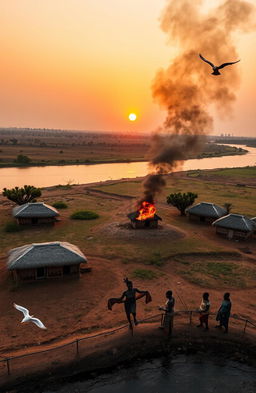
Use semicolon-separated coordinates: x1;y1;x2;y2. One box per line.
7;242;87;270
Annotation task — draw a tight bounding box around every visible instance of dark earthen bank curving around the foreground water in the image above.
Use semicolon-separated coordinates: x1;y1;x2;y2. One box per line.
2;324;256;393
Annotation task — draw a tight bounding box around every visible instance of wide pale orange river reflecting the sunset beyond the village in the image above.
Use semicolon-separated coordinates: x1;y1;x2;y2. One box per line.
0;145;256;191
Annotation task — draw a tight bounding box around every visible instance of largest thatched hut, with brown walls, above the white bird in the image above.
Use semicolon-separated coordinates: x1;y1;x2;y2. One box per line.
7;242;87;281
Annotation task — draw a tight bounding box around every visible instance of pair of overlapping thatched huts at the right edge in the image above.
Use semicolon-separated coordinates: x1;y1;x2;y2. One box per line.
186;202;256;240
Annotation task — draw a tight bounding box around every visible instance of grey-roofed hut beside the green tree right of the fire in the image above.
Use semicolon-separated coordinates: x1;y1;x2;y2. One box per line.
186;202;227;223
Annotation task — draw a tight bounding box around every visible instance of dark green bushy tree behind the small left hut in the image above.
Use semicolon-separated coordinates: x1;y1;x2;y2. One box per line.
3;185;41;205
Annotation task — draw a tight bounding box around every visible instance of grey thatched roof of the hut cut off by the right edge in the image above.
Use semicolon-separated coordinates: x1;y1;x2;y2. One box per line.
212;214;256;232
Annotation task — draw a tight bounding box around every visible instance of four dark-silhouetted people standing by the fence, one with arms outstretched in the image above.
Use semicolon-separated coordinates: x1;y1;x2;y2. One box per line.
108;278;232;336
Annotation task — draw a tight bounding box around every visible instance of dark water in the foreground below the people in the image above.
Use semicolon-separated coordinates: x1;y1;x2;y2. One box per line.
43;355;256;393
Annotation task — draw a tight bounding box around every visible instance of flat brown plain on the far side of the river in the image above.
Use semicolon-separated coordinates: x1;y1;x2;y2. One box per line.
0;130;248;167
